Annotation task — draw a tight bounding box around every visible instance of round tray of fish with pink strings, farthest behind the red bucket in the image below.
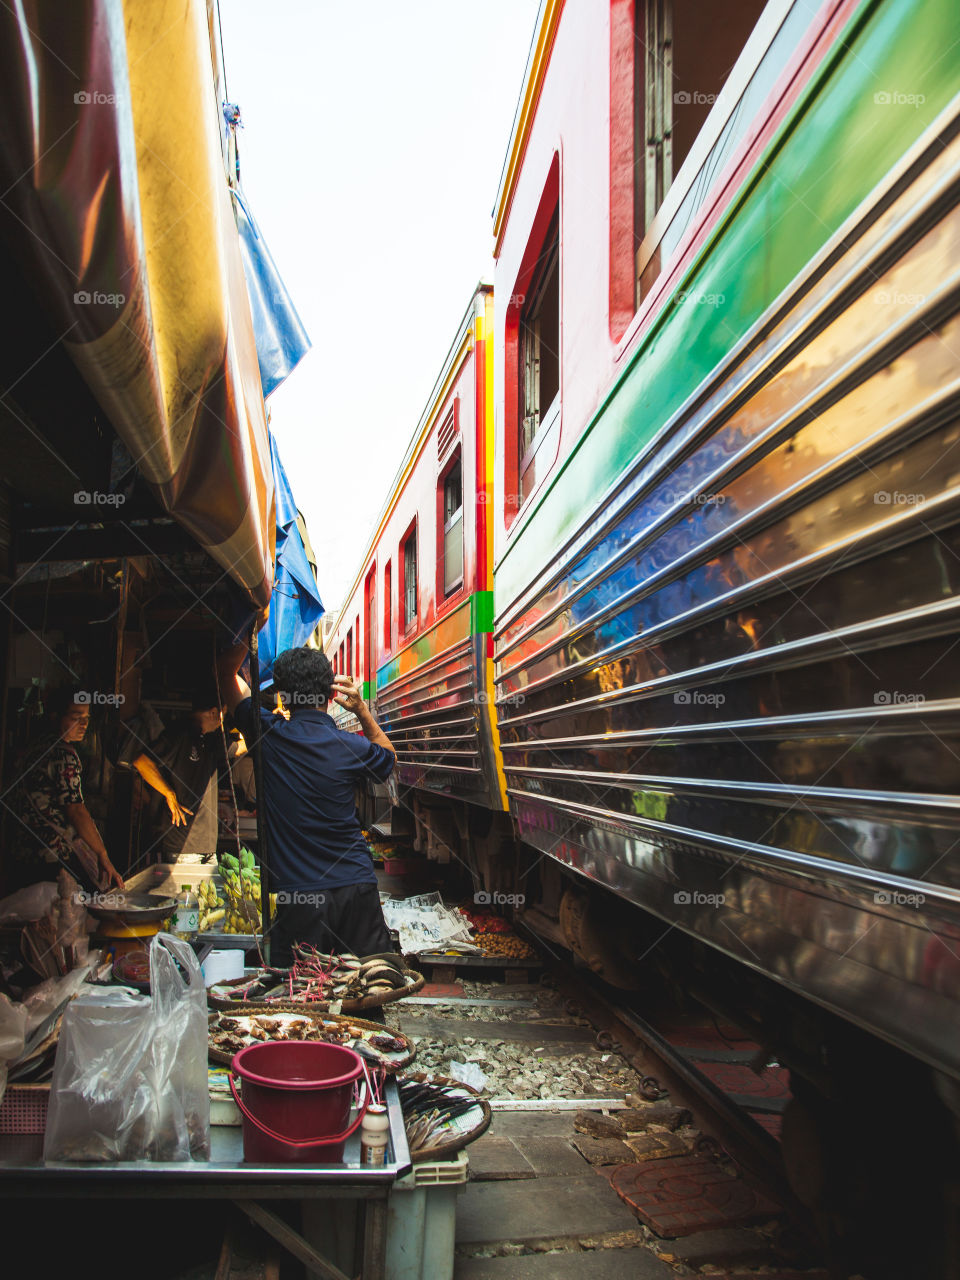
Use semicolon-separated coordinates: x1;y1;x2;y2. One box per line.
207;943;424;1012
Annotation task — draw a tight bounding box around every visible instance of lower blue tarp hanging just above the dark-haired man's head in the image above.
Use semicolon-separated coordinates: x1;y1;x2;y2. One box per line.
257;434;324;685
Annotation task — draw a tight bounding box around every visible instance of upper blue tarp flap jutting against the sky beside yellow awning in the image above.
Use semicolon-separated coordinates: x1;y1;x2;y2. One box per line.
233;188;310;399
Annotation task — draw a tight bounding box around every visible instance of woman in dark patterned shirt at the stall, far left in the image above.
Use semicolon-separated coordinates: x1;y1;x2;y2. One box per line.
5;691;123;892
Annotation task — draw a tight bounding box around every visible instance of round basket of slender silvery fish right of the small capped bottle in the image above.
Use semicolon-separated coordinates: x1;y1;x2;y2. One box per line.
397;1071;492;1165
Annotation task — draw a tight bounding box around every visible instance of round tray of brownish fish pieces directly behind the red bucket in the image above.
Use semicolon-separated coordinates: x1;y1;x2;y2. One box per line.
207;1011;416;1074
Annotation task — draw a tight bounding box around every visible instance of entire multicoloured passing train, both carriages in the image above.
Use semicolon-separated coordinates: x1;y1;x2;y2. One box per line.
328;0;960;1274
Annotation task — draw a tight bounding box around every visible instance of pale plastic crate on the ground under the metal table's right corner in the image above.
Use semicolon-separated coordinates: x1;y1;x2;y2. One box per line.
384;1151;470;1280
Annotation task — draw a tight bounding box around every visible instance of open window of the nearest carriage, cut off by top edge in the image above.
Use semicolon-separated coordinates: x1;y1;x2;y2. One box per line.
634;0;767;306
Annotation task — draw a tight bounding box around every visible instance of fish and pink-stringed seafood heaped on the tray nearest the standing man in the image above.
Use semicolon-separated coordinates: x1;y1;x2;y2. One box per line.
210;942;419;1006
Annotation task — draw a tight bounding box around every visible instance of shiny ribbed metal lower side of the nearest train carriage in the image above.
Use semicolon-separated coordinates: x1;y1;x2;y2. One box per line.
495;104;960;1070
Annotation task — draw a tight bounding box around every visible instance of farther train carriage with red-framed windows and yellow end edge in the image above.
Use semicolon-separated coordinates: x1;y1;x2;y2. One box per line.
325;285;506;860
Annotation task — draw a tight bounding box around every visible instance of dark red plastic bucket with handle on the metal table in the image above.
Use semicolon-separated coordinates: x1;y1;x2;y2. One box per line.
230;1041;370;1165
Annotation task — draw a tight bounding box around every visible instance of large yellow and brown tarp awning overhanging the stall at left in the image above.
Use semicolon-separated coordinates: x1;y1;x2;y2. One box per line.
0;0;275;604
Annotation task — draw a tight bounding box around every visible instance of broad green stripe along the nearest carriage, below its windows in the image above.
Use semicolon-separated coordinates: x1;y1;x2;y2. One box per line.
494;0;960;612
